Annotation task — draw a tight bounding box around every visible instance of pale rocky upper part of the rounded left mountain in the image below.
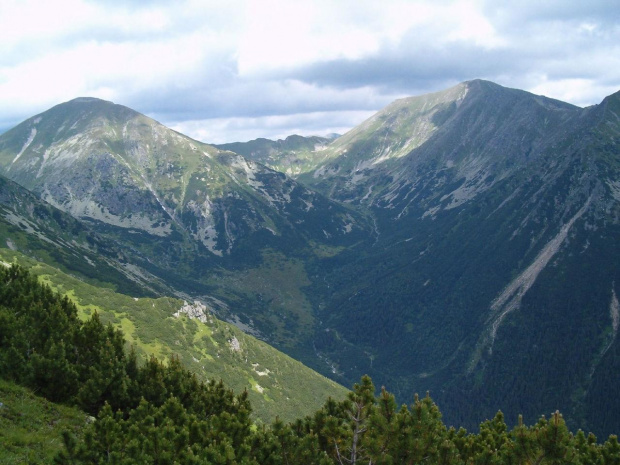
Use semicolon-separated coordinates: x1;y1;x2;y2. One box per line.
0;94;368;256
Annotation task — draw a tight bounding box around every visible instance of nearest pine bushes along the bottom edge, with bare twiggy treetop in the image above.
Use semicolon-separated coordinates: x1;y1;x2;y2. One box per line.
52;377;620;465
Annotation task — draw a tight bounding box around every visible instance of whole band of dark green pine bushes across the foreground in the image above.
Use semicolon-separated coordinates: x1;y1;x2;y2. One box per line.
0;265;620;465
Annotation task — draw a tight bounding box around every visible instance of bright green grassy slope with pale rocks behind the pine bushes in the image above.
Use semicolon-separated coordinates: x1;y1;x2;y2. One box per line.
0;249;347;423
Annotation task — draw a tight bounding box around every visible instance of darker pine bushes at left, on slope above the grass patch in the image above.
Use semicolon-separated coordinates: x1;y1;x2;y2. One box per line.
0;265;252;455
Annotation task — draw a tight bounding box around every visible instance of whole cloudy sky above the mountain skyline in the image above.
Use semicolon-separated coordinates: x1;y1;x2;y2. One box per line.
0;0;620;143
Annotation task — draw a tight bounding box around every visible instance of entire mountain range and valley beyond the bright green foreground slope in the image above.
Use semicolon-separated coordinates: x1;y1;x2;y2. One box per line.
0;80;620;435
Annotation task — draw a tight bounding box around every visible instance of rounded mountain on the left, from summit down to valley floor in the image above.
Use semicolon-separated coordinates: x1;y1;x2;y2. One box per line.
0;98;369;352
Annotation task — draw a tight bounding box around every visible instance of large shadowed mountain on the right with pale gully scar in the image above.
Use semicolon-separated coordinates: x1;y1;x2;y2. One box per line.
299;81;620;434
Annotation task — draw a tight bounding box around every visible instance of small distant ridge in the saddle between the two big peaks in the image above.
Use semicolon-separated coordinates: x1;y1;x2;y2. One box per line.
215;134;339;176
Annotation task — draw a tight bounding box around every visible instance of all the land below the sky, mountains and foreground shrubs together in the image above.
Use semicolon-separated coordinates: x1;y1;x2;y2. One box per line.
0;80;620;464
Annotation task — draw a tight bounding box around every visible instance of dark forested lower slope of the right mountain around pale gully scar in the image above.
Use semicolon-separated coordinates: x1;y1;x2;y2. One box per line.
315;158;620;437
